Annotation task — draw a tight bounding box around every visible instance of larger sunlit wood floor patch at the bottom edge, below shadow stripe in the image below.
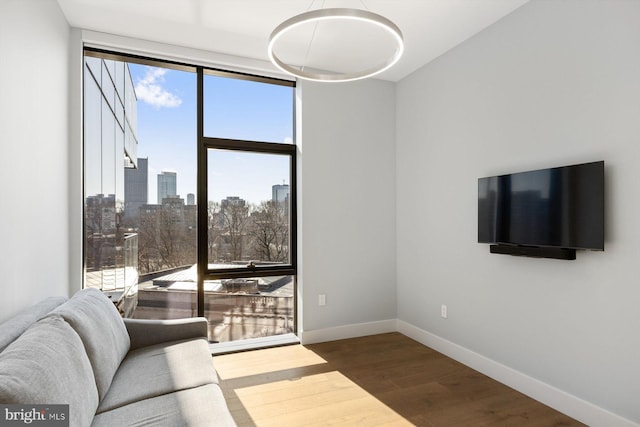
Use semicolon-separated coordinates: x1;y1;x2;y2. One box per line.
235;371;412;427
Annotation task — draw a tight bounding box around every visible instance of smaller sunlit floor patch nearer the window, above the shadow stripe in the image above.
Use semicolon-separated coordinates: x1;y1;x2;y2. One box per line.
213;345;327;380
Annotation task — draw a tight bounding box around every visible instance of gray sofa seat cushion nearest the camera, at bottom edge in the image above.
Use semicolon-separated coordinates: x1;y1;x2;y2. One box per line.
91;384;236;427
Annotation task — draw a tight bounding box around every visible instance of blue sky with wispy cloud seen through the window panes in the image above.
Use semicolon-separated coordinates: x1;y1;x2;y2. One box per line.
129;64;293;203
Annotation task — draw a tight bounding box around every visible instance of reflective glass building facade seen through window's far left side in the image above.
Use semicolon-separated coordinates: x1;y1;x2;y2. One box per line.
84;53;138;291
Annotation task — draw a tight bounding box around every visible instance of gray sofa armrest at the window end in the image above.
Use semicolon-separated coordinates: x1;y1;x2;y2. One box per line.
123;317;208;350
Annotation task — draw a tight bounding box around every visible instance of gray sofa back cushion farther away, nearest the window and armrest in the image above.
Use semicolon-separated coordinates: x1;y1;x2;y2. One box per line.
52;288;130;400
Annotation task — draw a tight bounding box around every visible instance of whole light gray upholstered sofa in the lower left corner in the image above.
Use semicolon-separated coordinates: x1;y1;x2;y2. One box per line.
0;289;235;427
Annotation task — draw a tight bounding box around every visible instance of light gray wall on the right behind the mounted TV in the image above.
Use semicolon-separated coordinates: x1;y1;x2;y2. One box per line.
396;0;640;422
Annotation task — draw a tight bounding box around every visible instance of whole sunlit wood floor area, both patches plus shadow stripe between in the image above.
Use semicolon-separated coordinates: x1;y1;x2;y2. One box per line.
213;345;412;427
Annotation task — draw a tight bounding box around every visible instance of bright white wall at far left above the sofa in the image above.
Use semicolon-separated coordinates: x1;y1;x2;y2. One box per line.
0;0;69;321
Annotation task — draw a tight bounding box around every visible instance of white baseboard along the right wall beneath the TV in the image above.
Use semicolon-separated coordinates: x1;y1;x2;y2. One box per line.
396;320;638;427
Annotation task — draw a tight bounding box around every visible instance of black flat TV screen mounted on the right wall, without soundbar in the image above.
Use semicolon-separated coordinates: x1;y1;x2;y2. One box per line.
478;161;604;250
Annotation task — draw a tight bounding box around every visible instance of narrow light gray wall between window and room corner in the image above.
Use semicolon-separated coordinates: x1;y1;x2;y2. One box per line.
299;80;396;337
